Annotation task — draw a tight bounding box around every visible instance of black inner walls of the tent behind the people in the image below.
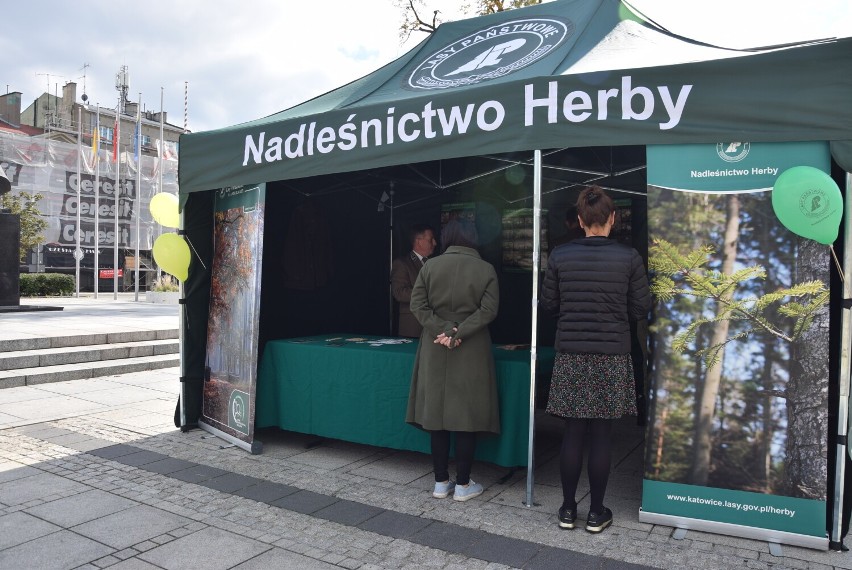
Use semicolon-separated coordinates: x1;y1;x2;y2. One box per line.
178;146;647;412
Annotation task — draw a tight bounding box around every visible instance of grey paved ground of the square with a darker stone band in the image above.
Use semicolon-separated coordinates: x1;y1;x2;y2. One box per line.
0;294;852;570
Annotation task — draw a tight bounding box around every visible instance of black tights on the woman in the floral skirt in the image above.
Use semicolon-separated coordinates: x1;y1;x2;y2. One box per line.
559;418;612;513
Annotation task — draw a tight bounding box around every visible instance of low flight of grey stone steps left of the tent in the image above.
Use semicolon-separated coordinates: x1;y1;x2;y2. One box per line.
0;329;180;388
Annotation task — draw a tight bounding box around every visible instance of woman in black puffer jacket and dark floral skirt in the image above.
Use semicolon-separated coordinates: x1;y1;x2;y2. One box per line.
541;186;651;532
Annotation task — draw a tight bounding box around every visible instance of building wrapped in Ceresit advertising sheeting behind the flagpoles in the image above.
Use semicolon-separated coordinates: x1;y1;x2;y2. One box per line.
0;82;184;291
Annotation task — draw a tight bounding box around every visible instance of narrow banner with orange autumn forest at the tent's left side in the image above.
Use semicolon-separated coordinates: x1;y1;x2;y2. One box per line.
200;184;266;453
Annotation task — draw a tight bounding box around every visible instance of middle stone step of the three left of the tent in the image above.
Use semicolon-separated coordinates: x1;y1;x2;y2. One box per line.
0;339;180;371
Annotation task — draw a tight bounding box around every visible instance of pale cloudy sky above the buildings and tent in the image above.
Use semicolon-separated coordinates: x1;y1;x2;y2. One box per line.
0;0;852;132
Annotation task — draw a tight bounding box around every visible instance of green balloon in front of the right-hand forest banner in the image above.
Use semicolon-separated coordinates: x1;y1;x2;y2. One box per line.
772;166;843;245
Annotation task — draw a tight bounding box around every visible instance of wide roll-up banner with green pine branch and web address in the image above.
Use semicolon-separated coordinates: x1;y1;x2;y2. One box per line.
639;142;828;548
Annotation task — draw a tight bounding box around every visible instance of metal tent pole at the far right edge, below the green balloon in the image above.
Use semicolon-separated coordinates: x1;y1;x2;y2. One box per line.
828;172;852;551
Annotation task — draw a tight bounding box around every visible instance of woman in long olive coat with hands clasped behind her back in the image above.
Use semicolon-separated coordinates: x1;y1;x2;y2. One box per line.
406;215;500;501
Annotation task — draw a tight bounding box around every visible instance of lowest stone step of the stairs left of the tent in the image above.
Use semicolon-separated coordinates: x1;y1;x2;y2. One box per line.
0;354;180;388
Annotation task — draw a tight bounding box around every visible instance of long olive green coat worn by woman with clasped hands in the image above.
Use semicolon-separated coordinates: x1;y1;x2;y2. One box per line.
405;246;500;433
